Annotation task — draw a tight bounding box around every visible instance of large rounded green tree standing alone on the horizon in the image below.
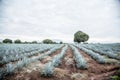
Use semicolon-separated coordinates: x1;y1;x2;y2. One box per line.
74;31;89;43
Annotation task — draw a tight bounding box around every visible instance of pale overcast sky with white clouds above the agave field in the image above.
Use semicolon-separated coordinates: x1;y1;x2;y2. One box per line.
0;0;120;42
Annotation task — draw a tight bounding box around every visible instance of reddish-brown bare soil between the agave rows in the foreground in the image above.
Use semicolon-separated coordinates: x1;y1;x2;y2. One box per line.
3;47;120;80
